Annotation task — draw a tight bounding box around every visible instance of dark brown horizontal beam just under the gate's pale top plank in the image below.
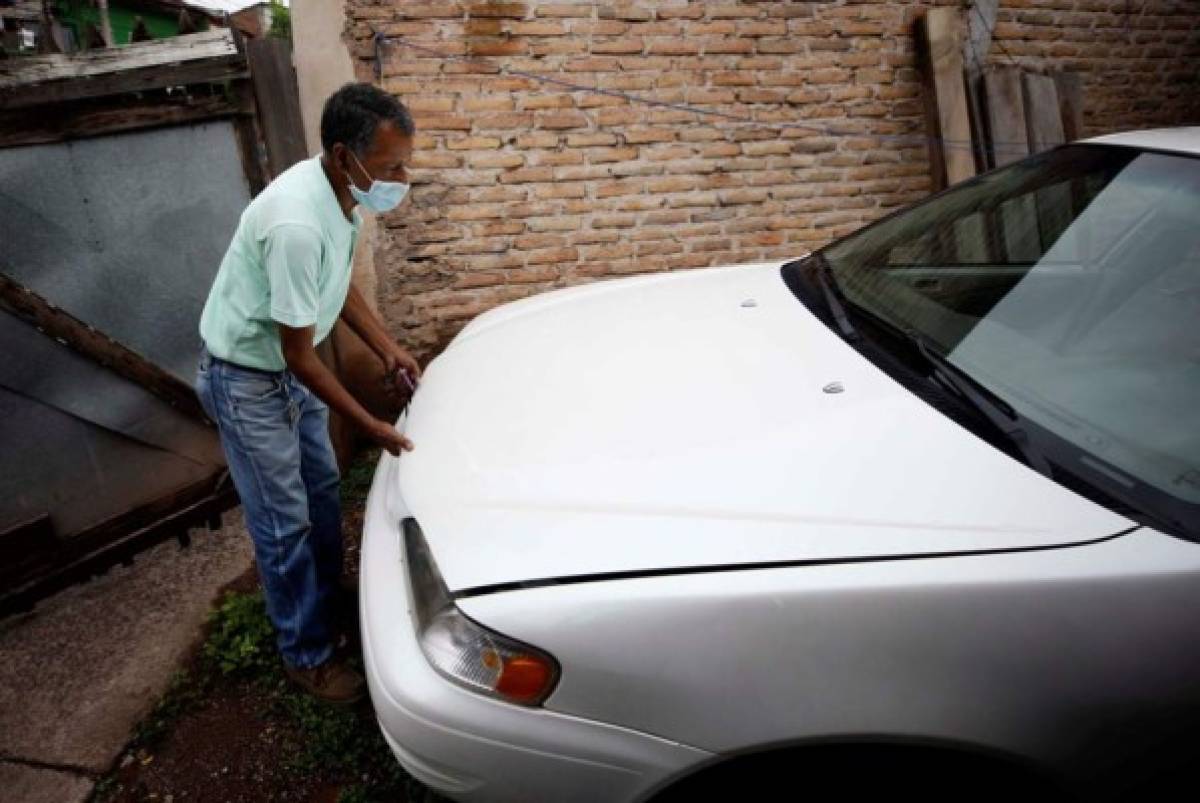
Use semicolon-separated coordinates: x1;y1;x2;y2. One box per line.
0;95;241;148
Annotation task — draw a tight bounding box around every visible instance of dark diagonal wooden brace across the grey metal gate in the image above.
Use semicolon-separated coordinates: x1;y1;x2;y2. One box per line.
0;274;208;423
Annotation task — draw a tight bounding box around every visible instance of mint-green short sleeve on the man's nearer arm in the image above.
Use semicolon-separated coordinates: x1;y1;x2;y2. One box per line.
263;223;322;329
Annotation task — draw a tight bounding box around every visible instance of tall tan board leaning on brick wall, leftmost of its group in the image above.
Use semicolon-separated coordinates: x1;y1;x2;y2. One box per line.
918;7;976;185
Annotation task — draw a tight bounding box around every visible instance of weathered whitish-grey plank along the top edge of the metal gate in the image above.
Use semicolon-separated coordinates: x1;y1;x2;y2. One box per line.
0;29;247;109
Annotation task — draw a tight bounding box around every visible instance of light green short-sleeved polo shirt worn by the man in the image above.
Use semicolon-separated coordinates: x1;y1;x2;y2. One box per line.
200;156;361;371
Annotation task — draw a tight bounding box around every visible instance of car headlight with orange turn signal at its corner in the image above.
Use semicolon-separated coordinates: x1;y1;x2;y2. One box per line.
403;519;558;706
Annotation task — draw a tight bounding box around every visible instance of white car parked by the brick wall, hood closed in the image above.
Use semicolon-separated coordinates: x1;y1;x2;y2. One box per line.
361;128;1200;803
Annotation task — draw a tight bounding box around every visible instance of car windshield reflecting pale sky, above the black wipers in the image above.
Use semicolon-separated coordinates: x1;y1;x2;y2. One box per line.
818;144;1200;538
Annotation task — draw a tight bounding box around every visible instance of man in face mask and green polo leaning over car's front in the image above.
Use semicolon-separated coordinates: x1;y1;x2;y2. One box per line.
197;84;420;702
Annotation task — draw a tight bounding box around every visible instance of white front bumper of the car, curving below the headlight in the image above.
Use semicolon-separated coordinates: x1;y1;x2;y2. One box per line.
359;455;712;803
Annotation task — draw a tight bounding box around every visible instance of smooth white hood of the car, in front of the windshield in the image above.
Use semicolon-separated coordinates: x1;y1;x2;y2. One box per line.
395;264;1132;591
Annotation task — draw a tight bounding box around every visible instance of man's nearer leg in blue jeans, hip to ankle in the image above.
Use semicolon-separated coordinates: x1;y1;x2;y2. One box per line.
202;362;332;669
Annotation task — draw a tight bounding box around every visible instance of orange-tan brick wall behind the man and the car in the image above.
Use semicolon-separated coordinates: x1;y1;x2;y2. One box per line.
348;0;1200;353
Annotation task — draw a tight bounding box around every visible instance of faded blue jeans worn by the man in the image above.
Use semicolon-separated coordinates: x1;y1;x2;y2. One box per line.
196;352;342;669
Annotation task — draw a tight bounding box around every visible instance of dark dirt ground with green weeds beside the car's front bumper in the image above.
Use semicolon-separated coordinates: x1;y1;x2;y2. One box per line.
92;453;439;803
